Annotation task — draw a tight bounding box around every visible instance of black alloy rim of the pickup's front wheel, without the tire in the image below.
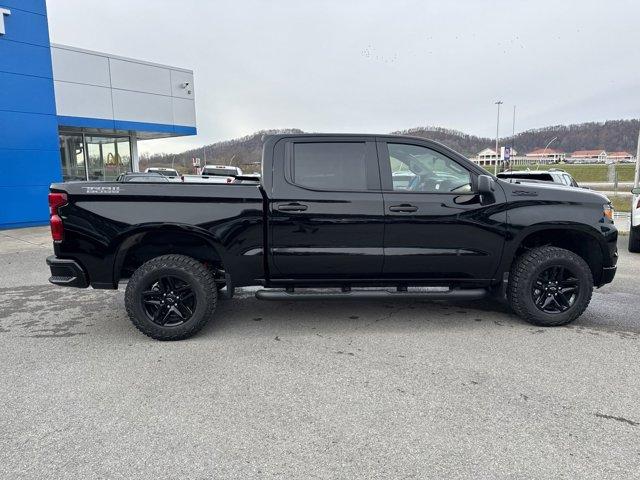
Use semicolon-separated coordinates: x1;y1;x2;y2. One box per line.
531;265;580;314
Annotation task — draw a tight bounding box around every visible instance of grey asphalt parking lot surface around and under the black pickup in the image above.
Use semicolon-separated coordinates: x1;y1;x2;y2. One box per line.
0;229;640;479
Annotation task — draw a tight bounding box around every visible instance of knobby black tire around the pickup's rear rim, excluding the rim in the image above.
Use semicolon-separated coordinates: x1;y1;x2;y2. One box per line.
124;255;218;340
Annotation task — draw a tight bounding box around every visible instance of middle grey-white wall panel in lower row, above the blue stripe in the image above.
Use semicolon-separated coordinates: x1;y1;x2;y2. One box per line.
113;90;173;125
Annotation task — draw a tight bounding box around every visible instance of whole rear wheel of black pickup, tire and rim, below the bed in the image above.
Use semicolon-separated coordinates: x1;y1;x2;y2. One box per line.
125;255;218;340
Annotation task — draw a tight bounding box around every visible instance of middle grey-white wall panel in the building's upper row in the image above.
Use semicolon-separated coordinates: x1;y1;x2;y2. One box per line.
109;58;171;96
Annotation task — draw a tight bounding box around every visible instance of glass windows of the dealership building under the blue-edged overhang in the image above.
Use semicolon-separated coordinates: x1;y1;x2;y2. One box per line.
60;133;132;182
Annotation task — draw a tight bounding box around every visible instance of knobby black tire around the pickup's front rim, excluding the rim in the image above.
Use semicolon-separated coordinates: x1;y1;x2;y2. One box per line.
507;246;593;327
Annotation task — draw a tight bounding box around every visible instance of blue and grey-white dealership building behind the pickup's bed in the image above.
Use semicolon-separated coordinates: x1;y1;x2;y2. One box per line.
0;0;196;228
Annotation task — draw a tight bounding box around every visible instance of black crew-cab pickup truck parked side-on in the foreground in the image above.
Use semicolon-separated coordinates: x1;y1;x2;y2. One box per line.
47;135;618;340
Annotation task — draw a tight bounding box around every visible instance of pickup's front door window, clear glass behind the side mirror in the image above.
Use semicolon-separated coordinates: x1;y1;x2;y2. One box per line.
387;143;472;193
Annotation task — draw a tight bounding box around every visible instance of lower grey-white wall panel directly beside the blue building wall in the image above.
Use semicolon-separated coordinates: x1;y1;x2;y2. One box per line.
54;80;113;120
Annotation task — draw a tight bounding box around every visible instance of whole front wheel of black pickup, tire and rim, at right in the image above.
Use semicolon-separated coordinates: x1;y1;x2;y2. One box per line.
507;247;593;327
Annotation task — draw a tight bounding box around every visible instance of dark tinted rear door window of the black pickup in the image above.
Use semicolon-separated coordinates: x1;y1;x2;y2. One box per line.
292;142;367;190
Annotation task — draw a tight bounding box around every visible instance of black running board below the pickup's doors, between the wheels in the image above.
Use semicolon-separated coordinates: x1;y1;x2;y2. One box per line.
256;288;488;300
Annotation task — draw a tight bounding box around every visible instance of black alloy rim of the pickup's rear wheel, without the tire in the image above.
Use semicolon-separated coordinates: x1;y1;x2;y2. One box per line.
141;275;197;327
